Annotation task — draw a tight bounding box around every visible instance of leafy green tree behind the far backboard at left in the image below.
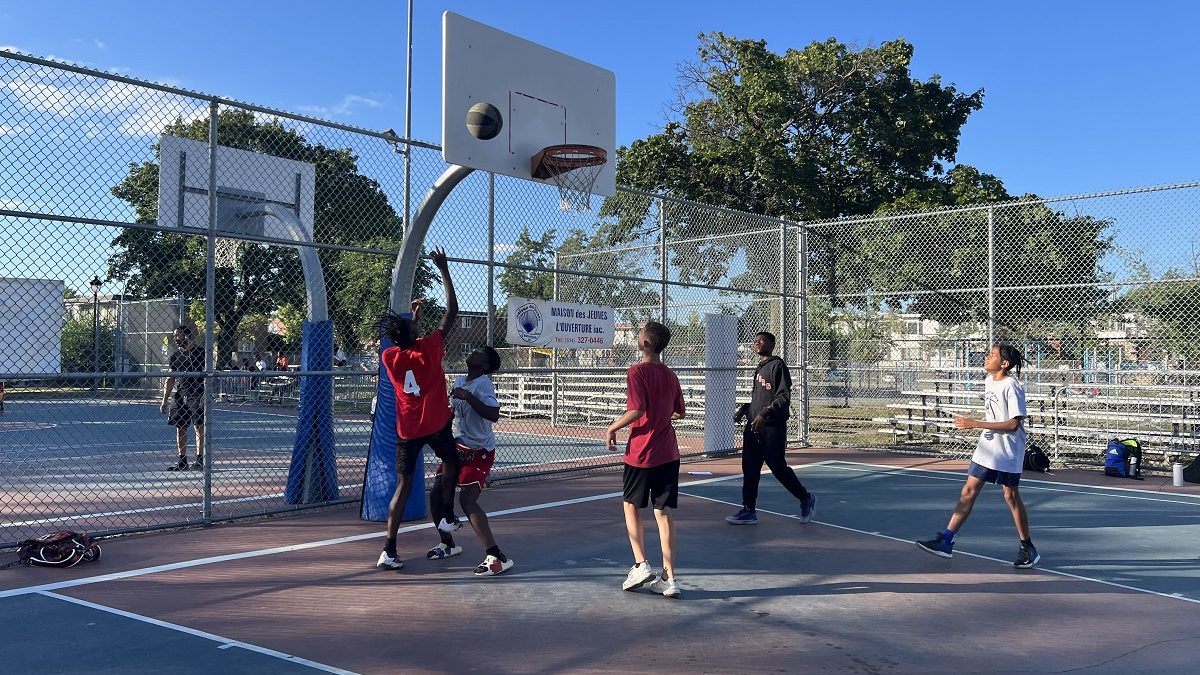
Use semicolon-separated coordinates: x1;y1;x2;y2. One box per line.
108;109;430;354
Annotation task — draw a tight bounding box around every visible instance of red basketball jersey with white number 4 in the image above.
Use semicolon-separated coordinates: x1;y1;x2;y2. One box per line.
380;330;450;440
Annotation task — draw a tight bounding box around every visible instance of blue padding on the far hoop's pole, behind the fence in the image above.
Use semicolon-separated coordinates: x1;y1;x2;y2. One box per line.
283;321;337;504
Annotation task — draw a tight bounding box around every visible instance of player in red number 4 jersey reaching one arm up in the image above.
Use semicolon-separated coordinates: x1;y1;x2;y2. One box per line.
376;247;462;569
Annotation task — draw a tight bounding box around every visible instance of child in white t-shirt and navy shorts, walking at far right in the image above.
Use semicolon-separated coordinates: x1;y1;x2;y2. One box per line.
917;345;1042;569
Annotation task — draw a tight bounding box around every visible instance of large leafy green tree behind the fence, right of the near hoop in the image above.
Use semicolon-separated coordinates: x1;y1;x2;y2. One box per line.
601;32;1109;345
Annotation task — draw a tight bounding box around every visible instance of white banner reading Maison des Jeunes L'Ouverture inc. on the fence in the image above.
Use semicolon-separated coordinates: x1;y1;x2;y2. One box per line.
506;298;614;350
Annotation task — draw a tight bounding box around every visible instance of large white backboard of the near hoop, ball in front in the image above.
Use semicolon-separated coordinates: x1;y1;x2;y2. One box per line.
442;12;617;197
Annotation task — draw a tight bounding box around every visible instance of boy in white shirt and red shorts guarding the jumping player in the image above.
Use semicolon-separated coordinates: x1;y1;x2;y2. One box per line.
425;347;514;577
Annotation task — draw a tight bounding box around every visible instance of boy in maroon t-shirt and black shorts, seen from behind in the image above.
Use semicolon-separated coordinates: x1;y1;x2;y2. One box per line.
608;321;685;598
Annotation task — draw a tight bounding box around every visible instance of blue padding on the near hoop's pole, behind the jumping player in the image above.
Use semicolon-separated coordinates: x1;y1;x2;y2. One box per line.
360;321;426;522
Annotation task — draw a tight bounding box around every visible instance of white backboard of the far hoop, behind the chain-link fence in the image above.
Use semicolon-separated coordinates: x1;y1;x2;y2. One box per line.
158;136;317;241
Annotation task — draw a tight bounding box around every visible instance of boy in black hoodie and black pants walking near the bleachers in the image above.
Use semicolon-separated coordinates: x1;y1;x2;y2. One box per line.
725;331;817;525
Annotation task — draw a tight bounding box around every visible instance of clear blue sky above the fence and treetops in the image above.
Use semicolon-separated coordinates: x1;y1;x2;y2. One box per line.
0;0;1200;196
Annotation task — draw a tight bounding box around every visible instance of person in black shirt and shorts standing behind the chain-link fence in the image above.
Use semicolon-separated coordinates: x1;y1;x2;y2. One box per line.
158;324;204;471
